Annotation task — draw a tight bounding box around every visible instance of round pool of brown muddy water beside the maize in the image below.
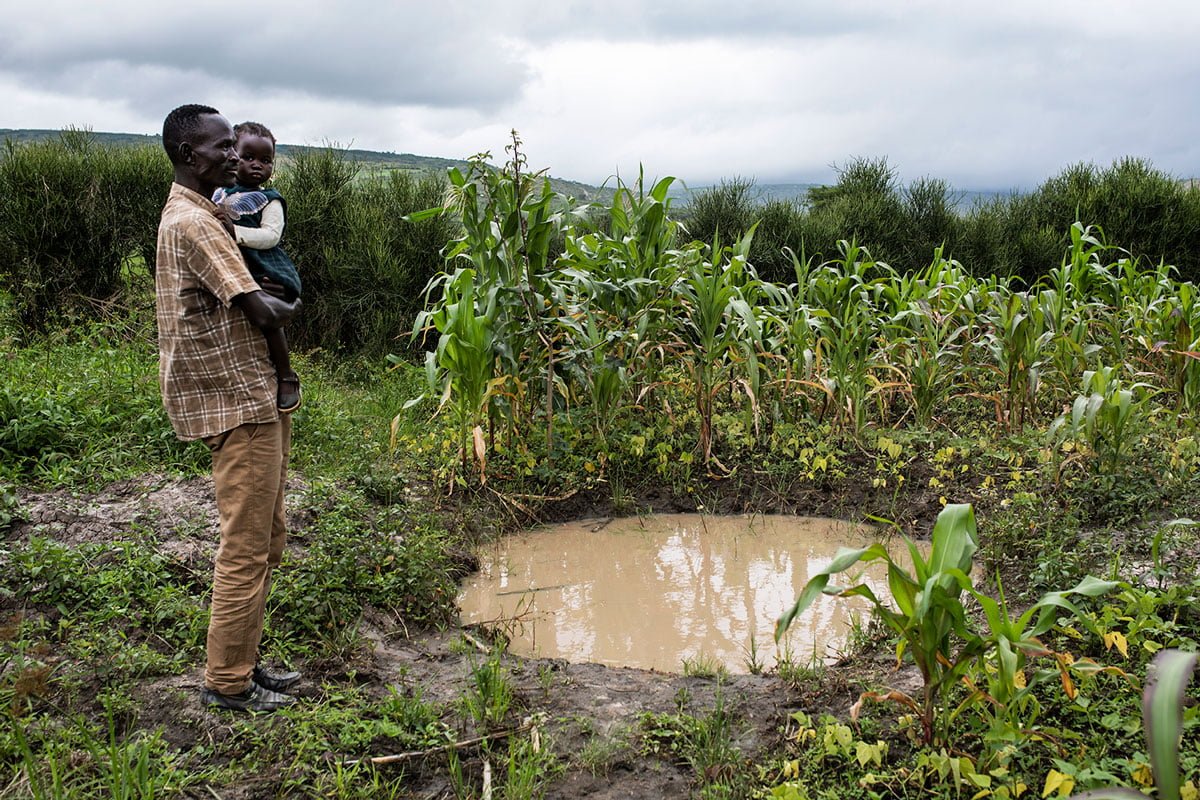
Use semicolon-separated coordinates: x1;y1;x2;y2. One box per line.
458;515;907;673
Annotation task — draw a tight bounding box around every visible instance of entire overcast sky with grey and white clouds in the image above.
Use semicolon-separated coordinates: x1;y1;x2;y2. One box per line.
0;0;1200;190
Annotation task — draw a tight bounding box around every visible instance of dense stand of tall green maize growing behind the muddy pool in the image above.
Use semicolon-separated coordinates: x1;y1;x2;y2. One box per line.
412;148;1200;470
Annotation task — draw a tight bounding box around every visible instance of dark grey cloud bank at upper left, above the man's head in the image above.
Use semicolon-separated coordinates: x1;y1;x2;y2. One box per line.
0;2;528;109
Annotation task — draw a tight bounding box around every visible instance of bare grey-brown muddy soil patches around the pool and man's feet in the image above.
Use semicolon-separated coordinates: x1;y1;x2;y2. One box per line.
8;476;919;799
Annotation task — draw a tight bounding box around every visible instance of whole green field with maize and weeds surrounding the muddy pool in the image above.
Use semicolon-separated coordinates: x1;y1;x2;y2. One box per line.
0;133;1200;800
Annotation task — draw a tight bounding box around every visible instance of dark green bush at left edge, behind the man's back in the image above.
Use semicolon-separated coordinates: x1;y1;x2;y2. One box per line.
0;131;172;331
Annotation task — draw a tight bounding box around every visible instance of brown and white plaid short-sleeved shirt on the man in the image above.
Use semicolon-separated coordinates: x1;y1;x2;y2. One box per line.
155;184;278;440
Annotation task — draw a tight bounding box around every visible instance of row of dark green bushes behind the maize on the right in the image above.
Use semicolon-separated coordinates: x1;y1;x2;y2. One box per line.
680;158;1200;285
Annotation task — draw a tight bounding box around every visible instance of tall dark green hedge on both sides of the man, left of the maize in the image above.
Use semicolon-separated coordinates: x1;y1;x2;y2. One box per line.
0;131;454;355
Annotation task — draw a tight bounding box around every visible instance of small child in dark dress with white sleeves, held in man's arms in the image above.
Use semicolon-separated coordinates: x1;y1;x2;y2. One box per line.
218;122;301;414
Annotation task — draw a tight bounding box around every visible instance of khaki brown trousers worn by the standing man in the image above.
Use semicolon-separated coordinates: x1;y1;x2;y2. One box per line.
204;415;292;694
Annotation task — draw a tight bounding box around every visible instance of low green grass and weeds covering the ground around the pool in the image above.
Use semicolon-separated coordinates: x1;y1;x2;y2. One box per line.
0;241;1200;798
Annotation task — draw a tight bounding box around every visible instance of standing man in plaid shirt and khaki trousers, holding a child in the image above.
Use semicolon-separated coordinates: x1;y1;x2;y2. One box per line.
155;106;300;711
